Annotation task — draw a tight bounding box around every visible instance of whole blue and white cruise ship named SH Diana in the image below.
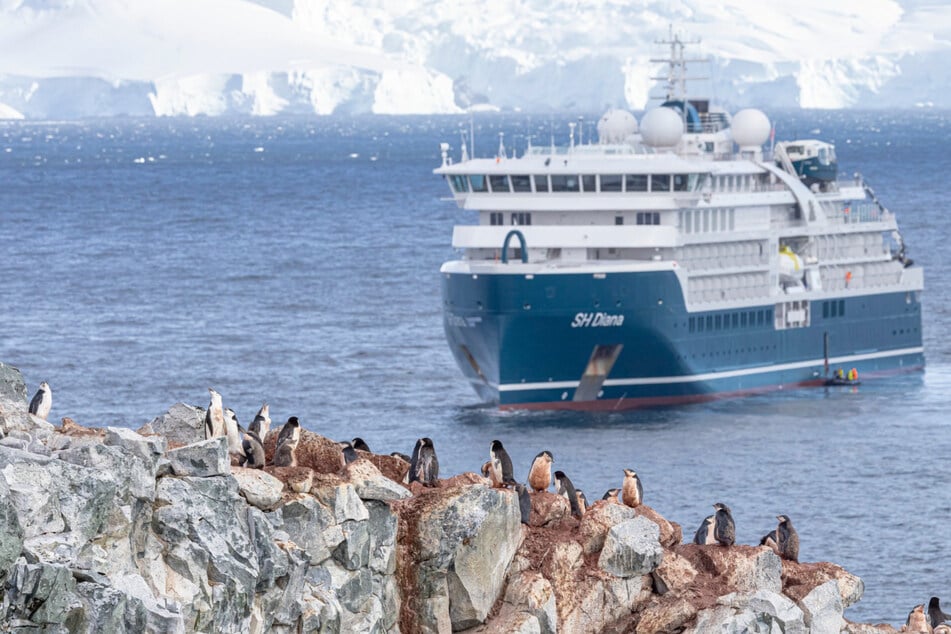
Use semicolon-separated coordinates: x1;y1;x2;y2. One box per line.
434;36;925;410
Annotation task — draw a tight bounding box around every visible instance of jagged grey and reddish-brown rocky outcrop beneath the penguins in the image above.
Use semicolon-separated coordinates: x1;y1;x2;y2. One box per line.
0;364;900;633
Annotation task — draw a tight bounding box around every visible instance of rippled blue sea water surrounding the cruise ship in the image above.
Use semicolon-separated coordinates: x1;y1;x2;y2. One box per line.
0;110;951;624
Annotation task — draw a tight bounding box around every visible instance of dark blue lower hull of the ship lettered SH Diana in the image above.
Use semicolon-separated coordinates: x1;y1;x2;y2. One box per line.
442;271;924;410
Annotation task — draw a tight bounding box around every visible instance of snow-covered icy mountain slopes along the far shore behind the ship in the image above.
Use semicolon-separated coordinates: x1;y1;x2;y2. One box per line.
0;0;951;119
